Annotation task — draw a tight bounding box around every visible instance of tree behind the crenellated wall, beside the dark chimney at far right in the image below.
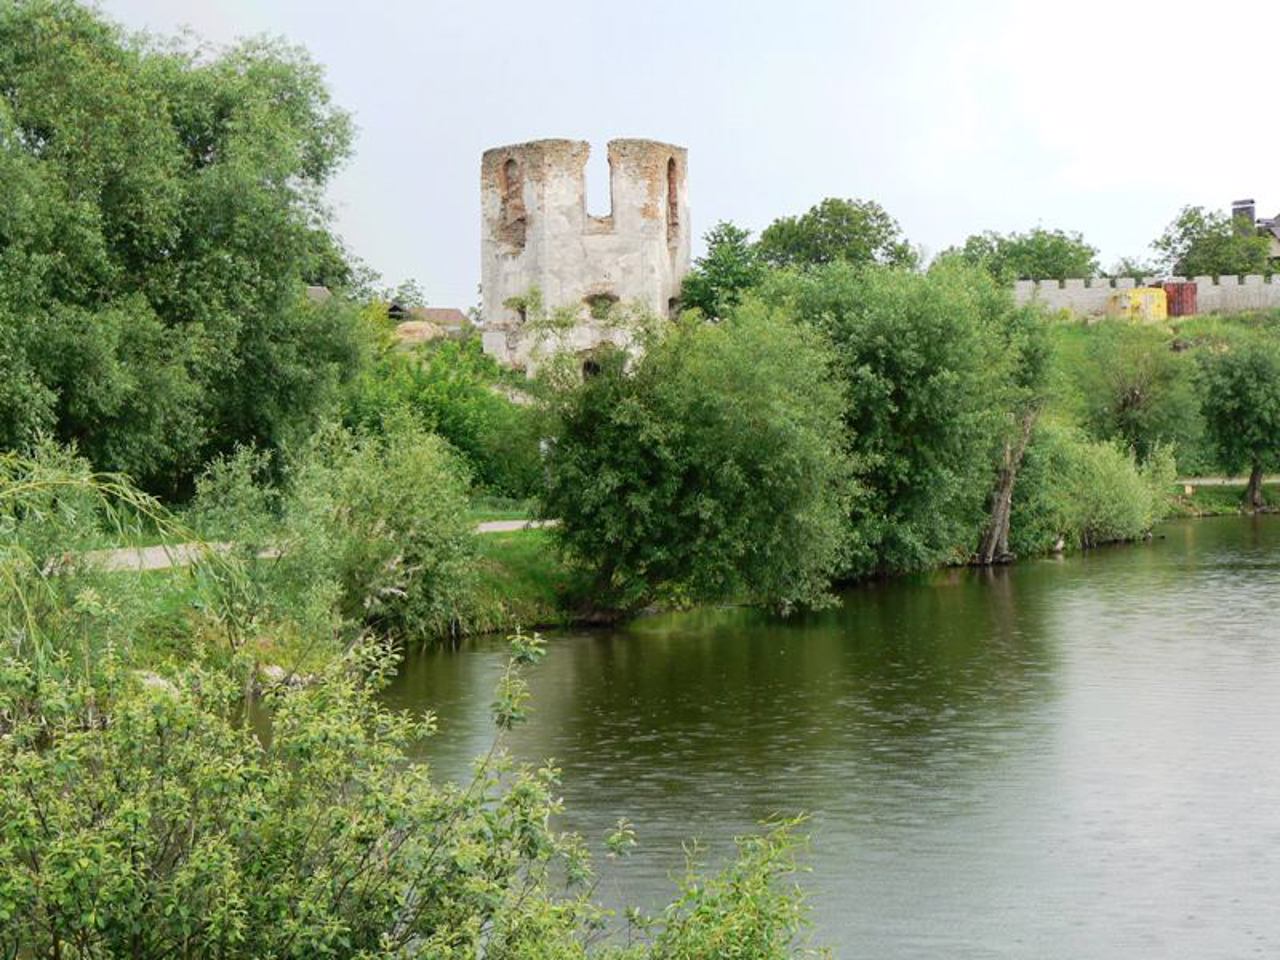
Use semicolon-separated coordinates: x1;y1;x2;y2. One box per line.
1151;206;1270;276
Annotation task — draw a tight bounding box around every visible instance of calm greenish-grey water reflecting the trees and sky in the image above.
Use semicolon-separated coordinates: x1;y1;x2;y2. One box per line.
389;517;1280;960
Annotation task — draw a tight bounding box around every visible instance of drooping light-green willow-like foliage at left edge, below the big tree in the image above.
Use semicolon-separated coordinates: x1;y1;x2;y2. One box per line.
0;440;247;677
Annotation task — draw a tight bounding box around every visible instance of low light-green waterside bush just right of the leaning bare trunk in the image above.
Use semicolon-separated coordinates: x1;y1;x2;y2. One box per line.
1010;420;1175;556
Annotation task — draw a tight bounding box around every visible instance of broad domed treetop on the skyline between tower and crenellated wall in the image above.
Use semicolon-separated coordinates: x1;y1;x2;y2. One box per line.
755;197;918;268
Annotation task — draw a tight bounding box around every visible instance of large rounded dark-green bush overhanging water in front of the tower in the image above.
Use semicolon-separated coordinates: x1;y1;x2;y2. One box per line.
541;303;849;609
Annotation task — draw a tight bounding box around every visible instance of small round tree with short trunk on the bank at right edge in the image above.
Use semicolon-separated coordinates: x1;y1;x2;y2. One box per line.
1201;337;1280;509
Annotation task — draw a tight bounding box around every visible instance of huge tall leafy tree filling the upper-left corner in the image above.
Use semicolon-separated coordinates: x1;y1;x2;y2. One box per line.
0;0;362;493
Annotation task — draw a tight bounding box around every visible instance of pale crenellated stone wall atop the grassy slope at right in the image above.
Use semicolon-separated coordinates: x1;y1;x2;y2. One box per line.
1014;275;1280;316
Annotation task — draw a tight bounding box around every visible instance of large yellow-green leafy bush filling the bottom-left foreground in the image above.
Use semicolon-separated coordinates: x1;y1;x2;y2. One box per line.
0;634;596;957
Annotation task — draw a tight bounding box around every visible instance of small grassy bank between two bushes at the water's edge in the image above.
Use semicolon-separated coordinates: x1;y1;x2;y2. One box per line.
476;530;588;631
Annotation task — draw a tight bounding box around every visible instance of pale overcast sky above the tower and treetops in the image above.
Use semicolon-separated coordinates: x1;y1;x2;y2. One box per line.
101;0;1280;307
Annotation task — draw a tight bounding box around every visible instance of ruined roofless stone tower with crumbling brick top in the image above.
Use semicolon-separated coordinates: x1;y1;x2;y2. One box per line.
480;140;689;370
